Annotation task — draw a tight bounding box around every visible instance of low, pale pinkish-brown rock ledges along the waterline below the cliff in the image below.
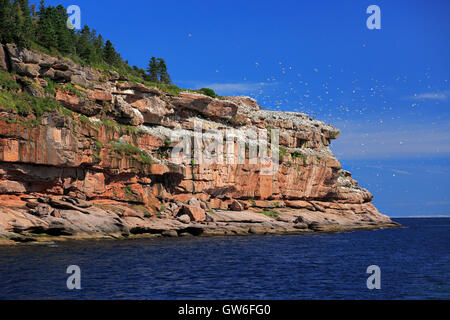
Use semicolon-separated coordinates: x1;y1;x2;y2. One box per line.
0;198;400;245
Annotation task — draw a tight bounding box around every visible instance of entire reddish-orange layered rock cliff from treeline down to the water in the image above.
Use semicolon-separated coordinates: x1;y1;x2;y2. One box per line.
0;44;395;239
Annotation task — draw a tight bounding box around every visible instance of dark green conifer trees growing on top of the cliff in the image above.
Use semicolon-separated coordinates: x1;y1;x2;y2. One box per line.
0;0;172;84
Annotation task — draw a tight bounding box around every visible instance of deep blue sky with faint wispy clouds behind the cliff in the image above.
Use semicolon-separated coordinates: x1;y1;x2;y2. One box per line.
36;0;450;216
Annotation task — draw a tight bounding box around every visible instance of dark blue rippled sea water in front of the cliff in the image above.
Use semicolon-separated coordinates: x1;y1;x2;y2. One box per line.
0;218;450;300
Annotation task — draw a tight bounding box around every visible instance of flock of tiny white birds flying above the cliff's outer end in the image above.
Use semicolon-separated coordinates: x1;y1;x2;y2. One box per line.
243;62;448;124
